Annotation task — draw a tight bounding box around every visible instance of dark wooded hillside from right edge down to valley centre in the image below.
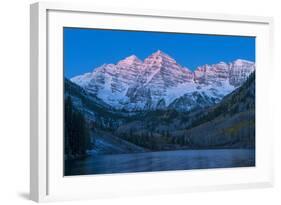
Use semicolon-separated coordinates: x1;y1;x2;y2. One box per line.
116;72;255;150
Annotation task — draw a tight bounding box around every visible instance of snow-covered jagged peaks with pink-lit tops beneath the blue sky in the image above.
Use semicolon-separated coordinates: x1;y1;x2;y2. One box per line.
71;50;255;111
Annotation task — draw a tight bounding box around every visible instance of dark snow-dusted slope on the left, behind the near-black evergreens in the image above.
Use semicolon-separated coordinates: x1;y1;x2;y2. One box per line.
64;79;147;157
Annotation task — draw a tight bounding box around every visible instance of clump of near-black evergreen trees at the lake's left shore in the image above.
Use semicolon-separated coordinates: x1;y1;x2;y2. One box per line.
64;96;91;158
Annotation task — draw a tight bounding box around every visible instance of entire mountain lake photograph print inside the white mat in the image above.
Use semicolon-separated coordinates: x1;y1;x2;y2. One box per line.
63;27;255;176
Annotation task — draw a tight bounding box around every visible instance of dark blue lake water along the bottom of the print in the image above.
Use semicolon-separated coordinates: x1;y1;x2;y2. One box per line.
65;149;255;176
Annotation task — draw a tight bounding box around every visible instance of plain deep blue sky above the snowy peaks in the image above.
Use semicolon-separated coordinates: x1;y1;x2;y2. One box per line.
64;28;255;78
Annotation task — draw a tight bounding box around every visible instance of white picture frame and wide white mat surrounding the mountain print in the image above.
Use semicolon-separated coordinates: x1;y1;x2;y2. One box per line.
30;2;273;202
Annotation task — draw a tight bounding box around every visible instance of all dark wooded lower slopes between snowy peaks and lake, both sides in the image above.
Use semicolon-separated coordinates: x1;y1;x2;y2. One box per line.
64;72;255;151
